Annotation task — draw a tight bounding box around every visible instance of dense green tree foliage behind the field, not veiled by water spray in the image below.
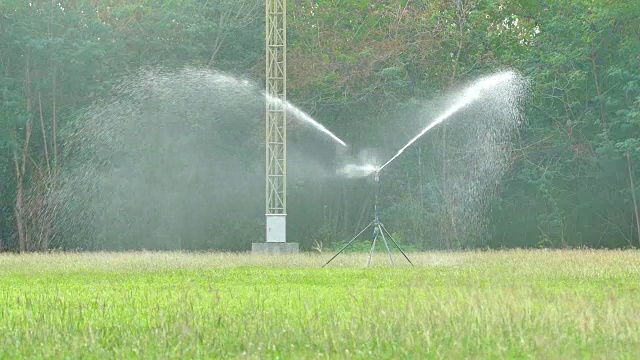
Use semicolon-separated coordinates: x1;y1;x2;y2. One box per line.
0;0;640;251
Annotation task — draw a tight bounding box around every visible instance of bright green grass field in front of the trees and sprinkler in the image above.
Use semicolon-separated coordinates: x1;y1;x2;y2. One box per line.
0;250;640;359
